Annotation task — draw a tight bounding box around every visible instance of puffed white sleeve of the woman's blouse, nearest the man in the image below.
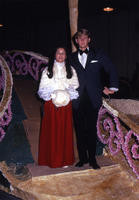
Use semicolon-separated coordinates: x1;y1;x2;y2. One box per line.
67;67;79;100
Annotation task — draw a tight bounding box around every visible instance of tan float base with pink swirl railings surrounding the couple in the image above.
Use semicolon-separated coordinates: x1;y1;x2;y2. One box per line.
0;51;139;200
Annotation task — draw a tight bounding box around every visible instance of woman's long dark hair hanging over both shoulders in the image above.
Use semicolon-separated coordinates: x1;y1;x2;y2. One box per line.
47;47;73;79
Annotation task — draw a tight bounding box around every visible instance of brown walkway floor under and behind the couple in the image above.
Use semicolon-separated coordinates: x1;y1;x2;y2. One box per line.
14;79;114;177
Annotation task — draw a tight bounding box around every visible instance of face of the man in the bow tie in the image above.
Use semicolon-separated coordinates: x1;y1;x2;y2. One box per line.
76;34;90;50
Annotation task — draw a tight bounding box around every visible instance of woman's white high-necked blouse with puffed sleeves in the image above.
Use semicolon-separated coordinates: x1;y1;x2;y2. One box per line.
38;61;79;104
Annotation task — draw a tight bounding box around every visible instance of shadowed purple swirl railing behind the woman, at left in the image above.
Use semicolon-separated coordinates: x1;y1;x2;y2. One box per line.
3;50;48;81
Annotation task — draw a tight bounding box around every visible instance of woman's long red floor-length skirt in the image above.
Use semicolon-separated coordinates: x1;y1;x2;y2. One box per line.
38;101;74;168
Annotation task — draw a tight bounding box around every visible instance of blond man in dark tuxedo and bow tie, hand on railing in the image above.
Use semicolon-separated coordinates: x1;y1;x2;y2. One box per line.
70;29;118;169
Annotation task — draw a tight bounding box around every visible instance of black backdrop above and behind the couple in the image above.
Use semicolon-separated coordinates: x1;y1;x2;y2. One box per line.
0;0;139;80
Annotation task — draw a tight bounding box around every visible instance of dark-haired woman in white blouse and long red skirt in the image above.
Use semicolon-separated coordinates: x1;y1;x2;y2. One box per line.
38;47;79;168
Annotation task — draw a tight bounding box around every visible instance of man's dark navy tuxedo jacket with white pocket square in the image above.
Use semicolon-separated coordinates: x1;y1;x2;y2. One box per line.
69;50;118;109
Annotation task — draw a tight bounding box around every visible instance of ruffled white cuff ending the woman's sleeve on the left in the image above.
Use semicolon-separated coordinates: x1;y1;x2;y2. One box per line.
38;87;53;101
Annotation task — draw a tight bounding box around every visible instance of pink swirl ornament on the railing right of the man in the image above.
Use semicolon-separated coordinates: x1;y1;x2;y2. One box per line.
97;106;139;179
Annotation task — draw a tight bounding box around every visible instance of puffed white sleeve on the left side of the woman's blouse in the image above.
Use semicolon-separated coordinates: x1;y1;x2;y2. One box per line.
38;68;53;101
